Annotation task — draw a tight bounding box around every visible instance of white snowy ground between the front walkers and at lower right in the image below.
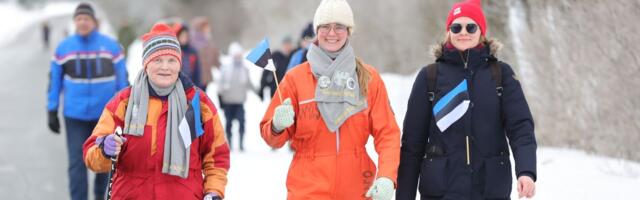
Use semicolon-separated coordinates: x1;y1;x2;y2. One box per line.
218;67;640;199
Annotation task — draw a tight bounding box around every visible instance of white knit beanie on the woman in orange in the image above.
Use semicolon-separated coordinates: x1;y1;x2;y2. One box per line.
313;0;355;34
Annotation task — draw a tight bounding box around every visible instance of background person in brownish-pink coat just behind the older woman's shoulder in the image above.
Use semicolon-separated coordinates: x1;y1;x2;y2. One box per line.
190;17;220;91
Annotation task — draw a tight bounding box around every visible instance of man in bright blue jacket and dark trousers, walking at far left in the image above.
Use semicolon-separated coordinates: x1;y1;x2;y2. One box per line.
47;3;129;200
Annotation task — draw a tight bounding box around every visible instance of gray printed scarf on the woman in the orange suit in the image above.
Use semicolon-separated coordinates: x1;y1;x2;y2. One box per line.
307;42;367;132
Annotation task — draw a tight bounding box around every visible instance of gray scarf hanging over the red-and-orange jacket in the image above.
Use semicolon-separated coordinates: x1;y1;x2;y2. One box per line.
124;70;189;178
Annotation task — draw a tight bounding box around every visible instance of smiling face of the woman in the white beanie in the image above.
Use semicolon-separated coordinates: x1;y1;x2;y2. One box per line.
317;23;349;52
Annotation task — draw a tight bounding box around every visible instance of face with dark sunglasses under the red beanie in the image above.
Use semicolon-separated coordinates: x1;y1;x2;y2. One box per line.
448;17;481;51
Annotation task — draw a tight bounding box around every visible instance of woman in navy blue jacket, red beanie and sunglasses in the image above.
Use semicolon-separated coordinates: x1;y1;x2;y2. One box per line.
396;0;537;200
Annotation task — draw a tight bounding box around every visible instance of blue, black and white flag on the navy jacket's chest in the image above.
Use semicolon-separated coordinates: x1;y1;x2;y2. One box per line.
433;79;471;132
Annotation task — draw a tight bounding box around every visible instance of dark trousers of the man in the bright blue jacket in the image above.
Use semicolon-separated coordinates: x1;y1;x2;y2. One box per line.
64;117;109;200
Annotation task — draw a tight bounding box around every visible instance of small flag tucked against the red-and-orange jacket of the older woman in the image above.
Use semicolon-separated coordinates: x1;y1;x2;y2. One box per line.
178;90;204;148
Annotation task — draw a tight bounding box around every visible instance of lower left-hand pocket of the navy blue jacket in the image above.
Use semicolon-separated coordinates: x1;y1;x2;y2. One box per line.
420;157;448;197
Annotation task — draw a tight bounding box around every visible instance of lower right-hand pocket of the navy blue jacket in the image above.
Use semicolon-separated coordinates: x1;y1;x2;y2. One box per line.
484;155;512;199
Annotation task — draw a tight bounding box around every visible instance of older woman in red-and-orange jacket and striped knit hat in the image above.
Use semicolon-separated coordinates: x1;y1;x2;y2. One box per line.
82;23;229;200
